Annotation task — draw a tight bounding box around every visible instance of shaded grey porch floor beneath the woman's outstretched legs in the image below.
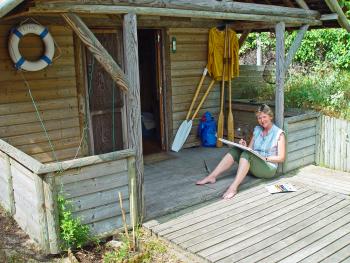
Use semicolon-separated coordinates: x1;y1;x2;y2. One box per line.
144;147;260;220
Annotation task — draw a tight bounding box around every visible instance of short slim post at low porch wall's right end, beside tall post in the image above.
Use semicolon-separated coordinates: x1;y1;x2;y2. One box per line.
128;156;141;227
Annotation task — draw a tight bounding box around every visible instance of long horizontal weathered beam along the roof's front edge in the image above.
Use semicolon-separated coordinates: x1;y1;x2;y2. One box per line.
36;0;320;18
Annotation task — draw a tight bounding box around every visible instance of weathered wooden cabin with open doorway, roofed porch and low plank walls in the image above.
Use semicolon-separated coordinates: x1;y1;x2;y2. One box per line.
0;0;350;253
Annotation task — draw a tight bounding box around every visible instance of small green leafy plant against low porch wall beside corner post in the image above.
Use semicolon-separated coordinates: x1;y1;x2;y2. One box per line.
57;194;90;250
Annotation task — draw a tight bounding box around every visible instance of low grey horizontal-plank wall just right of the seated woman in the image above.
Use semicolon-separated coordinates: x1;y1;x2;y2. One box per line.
283;114;318;173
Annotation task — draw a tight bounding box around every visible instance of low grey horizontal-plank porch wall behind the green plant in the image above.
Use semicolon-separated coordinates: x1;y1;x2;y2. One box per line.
55;159;130;235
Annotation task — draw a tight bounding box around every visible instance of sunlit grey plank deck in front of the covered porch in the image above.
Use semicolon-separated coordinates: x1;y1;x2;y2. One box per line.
144;166;350;263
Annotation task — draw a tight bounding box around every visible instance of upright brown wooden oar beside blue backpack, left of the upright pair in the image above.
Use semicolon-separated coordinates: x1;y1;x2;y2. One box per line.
216;25;227;148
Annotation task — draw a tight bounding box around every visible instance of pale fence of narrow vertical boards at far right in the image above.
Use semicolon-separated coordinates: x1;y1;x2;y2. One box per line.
316;116;350;172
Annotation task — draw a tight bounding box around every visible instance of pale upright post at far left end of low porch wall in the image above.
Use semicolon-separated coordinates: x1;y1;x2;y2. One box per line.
0;152;16;216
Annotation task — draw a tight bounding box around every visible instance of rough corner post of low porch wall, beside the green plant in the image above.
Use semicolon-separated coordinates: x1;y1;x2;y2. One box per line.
43;173;60;254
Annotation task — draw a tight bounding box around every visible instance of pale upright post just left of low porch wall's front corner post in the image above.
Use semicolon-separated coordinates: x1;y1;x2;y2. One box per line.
33;174;50;252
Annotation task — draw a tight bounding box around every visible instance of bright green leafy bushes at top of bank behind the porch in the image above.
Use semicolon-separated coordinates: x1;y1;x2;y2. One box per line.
240;28;350;69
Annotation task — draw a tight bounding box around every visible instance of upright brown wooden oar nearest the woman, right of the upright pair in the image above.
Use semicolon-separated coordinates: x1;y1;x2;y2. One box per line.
227;28;235;142
